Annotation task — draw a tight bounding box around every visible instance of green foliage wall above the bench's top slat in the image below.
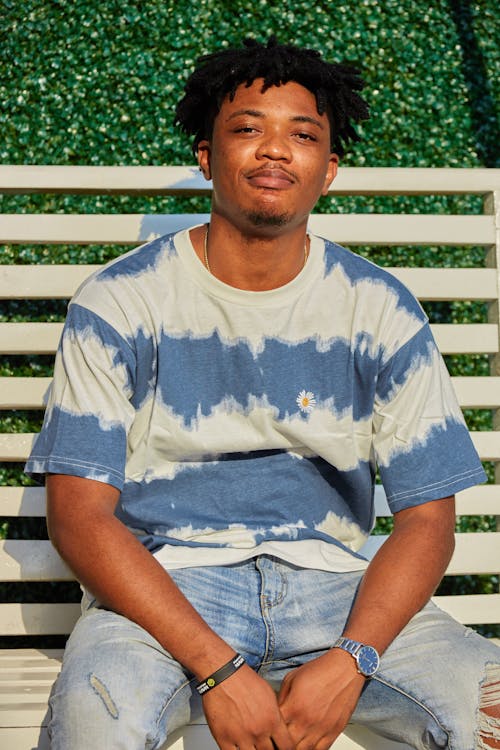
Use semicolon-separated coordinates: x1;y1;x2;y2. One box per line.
0;0;499;166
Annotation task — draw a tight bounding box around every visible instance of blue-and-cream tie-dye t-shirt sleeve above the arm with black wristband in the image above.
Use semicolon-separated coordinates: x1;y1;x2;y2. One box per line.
25;303;135;490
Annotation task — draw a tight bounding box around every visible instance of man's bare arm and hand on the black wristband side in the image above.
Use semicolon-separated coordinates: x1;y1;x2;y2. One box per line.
47;475;292;750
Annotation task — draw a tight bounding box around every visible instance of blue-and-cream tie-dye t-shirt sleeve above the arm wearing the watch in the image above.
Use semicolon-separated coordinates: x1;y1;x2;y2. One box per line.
373;323;486;512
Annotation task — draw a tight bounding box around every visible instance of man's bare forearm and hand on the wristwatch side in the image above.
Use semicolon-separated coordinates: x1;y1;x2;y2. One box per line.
278;497;455;750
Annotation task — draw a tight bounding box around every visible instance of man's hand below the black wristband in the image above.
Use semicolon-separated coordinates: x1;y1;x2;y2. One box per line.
203;666;295;750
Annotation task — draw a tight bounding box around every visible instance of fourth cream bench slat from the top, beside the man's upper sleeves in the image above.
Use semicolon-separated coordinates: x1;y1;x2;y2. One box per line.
0;323;499;354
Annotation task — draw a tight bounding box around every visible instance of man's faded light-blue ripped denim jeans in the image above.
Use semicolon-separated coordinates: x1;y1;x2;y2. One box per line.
49;556;500;750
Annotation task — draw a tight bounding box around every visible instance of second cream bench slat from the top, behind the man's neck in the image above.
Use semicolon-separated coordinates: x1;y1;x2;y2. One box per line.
0;214;496;246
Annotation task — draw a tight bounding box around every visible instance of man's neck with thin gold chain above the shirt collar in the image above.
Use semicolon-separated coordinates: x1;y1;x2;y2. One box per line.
190;217;309;292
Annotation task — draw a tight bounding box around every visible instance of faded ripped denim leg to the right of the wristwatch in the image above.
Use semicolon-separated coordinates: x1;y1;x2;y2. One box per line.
353;603;500;750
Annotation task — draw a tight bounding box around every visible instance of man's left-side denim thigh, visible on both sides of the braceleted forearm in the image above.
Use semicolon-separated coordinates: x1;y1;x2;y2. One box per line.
49;562;266;750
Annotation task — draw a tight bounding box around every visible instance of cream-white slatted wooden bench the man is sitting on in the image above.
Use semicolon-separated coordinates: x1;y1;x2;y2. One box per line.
0;166;500;750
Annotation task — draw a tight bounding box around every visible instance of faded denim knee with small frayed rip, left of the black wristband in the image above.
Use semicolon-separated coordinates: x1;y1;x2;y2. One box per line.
49;607;195;750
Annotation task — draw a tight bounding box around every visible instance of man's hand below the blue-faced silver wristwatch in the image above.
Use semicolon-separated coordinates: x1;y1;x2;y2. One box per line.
278;648;365;750
